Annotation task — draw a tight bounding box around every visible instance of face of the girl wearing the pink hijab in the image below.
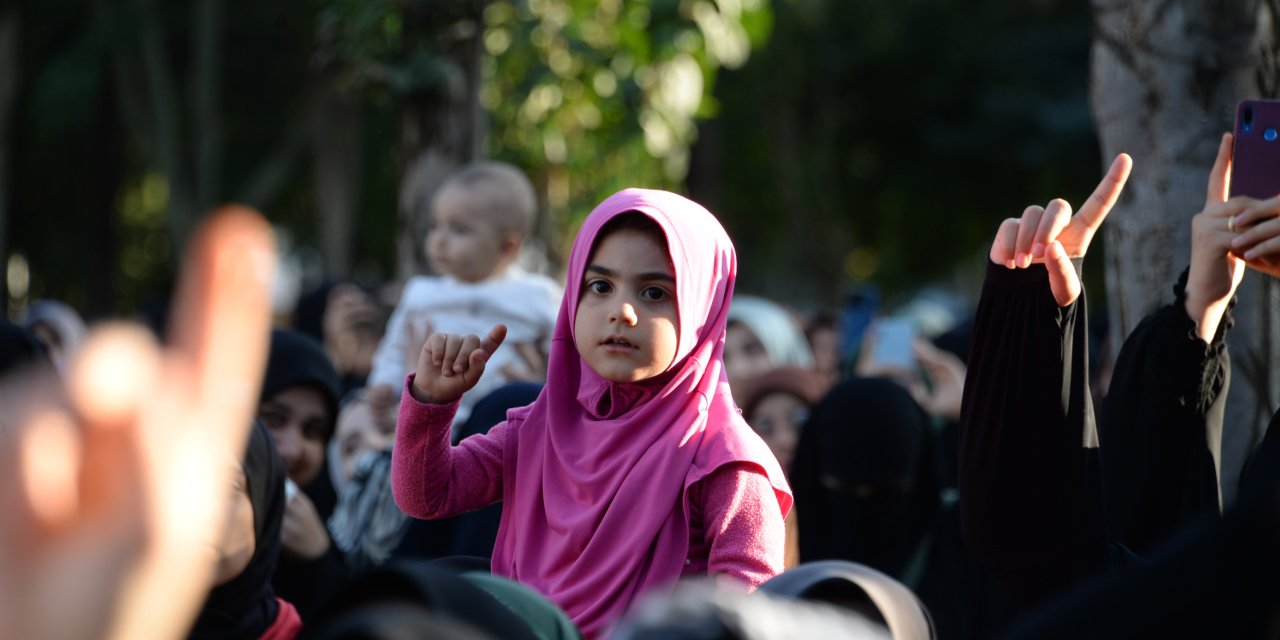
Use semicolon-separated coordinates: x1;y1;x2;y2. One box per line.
573;229;680;383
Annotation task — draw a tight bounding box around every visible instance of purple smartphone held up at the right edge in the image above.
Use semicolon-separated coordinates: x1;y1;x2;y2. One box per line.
1231;100;1280;198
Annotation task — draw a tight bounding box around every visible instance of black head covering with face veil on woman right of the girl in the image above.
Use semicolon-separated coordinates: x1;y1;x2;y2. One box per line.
791;378;940;585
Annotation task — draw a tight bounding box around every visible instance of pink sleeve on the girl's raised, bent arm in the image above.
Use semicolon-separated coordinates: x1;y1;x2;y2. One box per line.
392;374;508;520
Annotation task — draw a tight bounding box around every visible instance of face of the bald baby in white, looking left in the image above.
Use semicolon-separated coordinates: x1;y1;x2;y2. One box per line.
425;186;515;283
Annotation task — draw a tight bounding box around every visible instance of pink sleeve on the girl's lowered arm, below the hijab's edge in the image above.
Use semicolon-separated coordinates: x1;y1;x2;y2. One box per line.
694;463;786;589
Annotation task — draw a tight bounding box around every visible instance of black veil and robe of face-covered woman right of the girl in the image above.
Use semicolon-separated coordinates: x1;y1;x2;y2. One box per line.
790;378;1009;639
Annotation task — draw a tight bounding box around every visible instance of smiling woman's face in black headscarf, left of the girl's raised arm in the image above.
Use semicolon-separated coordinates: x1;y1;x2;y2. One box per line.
257;385;333;486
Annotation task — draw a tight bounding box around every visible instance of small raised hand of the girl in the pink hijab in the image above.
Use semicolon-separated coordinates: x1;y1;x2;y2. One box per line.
410;324;507;404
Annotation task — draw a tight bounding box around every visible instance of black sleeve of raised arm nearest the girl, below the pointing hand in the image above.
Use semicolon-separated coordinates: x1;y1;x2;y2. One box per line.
959;258;1107;605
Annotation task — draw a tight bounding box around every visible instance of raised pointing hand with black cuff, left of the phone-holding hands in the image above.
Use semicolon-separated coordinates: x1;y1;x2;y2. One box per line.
991;154;1133;307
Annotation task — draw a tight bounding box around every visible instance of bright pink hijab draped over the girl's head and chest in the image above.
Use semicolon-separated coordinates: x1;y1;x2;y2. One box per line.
493;189;791;637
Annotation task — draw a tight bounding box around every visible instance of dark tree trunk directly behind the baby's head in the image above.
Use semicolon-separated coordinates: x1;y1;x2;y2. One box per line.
396;6;485;280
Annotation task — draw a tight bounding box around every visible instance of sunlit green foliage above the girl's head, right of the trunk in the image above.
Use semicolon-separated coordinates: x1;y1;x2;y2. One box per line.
481;0;772;253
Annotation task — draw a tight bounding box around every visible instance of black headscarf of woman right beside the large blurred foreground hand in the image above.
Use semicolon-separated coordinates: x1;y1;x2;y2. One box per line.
191;420;284;639
